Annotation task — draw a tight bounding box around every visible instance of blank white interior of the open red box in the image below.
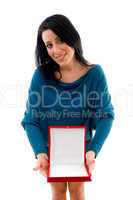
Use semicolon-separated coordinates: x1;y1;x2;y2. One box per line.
50;127;88;177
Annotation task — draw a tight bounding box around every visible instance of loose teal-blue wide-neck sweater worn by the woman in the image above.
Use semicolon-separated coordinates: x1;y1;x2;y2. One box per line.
21;64;114;158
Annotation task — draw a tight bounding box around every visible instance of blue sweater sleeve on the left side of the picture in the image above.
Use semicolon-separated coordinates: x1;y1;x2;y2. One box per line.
21;69;47;158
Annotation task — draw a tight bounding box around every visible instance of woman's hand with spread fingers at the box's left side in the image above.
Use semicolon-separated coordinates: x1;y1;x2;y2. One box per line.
33;153;48;177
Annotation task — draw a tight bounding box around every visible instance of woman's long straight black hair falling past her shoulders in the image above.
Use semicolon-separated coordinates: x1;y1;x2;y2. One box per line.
35;14;92;80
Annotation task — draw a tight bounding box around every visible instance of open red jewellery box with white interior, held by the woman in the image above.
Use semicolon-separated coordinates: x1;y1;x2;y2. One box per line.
47;126;91;182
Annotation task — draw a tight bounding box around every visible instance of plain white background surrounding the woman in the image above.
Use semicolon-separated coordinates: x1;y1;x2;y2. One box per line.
0;0;133;200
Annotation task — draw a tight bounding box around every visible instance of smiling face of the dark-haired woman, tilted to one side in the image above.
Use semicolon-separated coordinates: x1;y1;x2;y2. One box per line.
42;29;75;66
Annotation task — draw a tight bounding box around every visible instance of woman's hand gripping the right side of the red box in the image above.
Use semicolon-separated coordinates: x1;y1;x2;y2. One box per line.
86;151;95;173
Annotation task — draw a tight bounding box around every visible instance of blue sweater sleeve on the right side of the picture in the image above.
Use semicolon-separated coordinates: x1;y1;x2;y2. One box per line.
87;67;114;157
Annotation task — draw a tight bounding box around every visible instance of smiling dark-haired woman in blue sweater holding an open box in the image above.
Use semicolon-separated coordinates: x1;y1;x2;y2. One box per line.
21;14;114;200
